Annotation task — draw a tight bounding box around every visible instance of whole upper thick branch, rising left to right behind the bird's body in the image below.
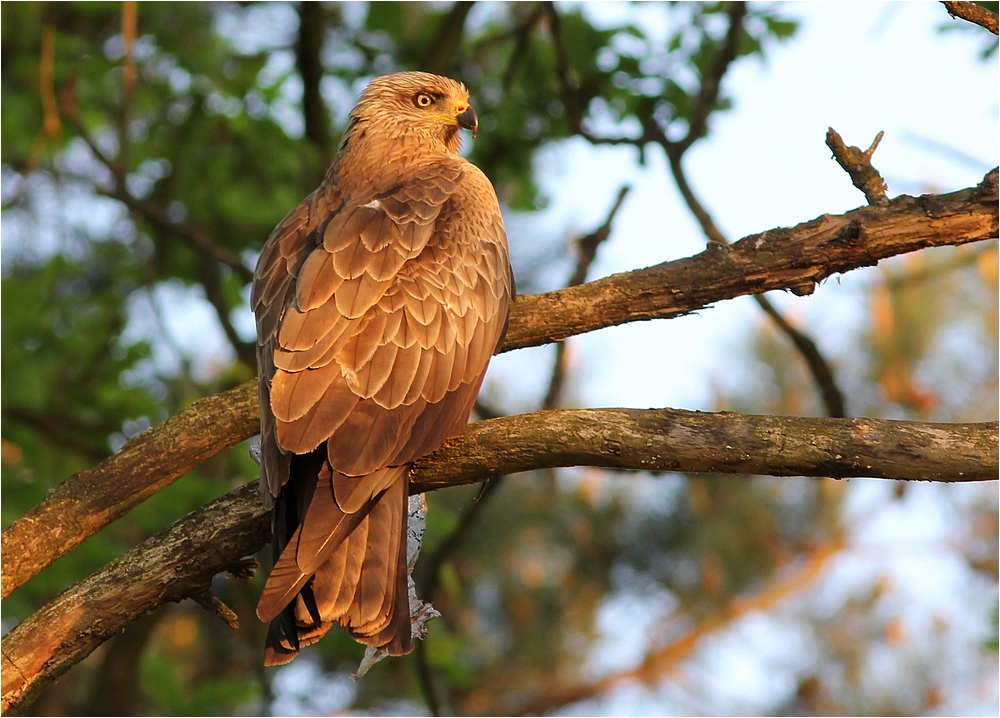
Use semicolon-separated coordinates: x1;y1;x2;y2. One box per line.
0;170;998;597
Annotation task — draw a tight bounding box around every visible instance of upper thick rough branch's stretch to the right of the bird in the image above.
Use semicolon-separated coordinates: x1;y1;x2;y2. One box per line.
504;174;998;350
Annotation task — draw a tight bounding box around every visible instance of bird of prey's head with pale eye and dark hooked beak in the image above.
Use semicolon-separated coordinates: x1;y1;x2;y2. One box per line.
351;72;479;152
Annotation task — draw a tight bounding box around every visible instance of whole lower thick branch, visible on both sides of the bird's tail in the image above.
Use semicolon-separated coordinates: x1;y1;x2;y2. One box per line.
2;409;998;712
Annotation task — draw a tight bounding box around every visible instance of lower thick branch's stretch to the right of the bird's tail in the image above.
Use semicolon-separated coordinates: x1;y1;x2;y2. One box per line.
413;409;998;492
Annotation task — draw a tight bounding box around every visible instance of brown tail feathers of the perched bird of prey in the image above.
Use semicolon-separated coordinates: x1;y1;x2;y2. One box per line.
257;457;412;666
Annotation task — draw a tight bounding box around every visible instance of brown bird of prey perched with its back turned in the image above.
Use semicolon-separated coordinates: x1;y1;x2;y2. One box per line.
251;72;514;665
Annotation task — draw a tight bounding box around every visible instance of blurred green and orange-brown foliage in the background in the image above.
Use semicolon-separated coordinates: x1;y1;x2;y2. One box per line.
0;2;997;715
